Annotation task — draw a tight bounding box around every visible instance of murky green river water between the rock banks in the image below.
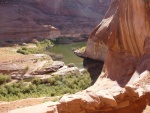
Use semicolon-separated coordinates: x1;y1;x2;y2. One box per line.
50;42;86;68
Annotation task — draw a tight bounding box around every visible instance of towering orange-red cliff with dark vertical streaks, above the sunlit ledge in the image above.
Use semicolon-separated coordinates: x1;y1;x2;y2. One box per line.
85;0;150;84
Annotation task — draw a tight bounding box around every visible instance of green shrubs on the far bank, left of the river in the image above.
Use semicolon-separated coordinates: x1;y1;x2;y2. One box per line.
17;39;53;55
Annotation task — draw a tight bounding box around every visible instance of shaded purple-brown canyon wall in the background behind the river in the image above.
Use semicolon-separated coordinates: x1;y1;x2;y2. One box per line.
0;0;111;43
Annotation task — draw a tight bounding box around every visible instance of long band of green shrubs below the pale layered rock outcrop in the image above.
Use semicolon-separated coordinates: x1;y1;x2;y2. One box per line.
0;73;91;101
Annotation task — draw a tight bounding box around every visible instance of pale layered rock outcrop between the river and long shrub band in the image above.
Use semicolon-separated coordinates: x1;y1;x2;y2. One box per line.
0;49;83;82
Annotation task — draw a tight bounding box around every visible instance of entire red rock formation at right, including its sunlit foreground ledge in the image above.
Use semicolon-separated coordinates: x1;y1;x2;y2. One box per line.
47;0;150;113
